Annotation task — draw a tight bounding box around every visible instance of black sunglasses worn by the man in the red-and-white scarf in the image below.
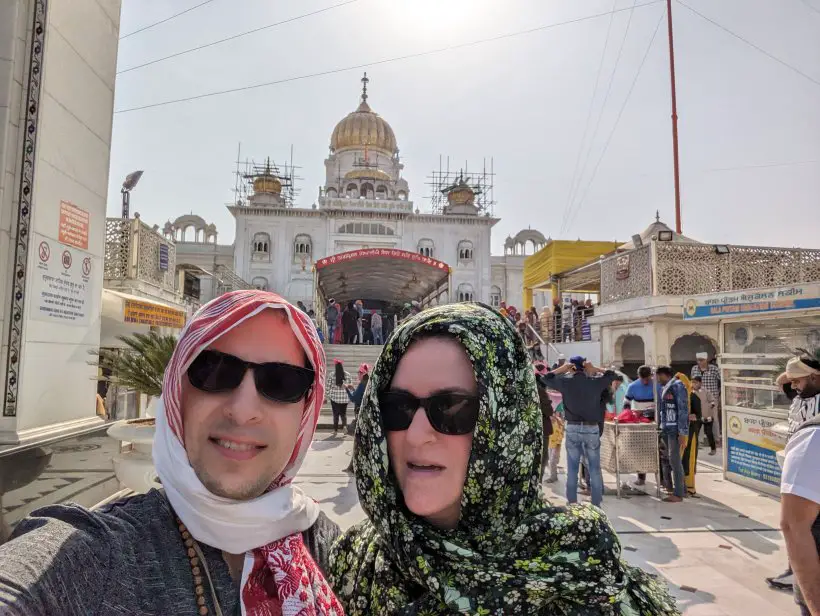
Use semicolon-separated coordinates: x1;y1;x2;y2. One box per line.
188;349;315;402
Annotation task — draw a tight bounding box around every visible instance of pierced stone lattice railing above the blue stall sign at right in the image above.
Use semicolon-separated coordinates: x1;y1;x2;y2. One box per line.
601;241;820;304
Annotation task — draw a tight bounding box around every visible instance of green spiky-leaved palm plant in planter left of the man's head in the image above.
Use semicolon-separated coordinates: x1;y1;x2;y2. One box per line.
91;332;177;396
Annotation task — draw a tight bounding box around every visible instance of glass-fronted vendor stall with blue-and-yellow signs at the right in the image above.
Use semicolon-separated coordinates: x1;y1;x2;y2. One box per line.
684;283;820;495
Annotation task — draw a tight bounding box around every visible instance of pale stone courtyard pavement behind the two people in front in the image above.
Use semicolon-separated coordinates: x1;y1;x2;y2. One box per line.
297;435;799;616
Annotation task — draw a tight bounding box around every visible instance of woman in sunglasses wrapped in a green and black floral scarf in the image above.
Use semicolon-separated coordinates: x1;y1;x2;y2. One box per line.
330;304;678;616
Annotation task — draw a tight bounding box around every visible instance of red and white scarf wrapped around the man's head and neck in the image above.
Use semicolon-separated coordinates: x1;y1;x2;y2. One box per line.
153;290;344;616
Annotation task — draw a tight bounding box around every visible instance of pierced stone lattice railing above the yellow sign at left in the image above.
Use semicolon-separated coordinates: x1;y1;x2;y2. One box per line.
103;218;176;293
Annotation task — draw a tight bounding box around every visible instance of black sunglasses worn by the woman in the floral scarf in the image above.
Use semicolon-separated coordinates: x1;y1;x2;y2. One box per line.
379;391;479;435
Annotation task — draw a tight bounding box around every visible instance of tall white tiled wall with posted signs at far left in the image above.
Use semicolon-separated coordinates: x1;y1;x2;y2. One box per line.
1;0;120;438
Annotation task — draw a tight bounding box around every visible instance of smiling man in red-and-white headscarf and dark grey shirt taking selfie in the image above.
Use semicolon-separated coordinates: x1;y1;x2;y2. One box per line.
0;290;343;616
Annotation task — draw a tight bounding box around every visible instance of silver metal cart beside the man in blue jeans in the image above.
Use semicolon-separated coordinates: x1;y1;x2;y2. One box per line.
601;421;661;498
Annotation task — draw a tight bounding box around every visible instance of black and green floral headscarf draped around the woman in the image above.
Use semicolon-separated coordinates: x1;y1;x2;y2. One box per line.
330;304;679;616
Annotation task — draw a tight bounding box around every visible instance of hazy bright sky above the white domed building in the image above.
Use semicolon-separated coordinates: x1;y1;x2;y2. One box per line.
108;0;820;254
